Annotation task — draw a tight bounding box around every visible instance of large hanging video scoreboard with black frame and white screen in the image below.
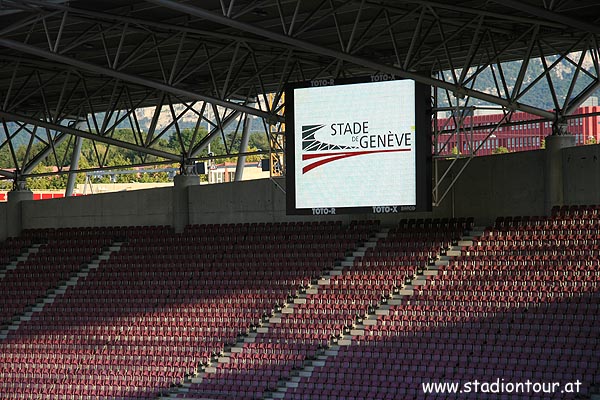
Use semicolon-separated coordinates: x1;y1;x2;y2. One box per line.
285;75;431;214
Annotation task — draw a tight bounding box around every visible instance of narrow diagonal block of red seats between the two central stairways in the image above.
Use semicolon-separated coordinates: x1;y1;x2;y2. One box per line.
184;220;464;398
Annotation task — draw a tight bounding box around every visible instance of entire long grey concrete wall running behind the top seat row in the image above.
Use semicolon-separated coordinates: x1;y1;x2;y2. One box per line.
0;145;600;240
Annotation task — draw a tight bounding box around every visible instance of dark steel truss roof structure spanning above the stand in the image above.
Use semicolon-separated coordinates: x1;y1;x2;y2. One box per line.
0;0;600;192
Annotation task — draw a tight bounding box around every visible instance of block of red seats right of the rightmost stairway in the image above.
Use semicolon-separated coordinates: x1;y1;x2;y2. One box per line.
286;214;600;399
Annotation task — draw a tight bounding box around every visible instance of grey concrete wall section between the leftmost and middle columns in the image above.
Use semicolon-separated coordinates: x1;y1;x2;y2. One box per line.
22;188;172;229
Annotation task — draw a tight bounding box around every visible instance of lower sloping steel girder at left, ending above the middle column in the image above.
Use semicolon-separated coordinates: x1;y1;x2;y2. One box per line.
0;110;182;162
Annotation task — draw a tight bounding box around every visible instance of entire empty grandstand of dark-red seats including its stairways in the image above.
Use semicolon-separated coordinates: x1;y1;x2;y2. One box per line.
0;211;600;399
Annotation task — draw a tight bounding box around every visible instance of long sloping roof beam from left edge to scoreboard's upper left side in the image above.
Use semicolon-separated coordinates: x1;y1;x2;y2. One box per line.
0;38;283;122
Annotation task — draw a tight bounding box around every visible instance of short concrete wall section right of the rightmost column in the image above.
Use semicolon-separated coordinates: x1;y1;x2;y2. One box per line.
563;145;600;204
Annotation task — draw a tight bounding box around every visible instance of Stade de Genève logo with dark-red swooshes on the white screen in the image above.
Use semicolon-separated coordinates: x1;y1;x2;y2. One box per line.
302;121;411;174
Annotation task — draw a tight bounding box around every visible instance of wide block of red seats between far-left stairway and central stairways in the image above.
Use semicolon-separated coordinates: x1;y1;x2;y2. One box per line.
0;222;378;398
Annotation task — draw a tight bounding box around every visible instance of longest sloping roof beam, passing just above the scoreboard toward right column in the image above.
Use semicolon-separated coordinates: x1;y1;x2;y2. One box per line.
145;0;554;119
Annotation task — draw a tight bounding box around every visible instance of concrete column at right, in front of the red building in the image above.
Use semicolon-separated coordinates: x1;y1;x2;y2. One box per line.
544;135;575;215
